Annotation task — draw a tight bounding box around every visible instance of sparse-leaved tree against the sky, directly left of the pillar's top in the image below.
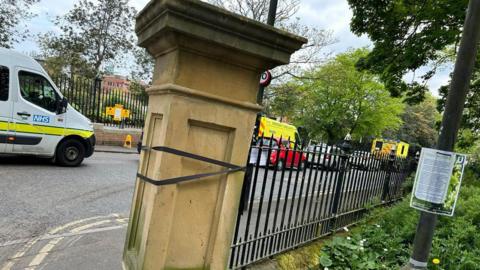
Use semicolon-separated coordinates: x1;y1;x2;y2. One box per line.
40;0;136;75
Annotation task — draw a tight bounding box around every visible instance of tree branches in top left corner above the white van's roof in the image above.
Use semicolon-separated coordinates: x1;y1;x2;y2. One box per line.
0;0;39;48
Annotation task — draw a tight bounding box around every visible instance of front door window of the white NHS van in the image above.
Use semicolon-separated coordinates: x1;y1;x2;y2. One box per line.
18;71;59;112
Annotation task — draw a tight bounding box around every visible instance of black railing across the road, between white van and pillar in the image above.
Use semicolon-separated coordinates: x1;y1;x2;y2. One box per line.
52;76;148;128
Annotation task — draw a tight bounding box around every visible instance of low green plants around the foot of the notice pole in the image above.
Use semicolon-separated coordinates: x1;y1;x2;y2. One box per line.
319;170;480;270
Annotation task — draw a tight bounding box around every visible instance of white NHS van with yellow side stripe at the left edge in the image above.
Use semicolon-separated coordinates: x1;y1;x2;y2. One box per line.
0;48;95;167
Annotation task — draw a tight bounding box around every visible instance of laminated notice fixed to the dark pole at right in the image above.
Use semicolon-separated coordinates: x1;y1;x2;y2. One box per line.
410;148;467;216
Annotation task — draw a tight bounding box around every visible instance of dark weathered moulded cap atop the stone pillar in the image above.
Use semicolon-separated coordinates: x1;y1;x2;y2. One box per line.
135;0;307;68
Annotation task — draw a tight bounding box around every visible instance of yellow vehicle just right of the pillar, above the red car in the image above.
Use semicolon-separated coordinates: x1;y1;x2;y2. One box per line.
257;116;298;143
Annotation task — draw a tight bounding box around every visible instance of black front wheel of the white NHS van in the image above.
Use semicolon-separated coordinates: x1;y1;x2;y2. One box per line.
56;140;85;167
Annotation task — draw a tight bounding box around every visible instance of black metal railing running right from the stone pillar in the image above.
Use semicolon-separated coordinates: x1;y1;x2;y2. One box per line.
229;137;411;269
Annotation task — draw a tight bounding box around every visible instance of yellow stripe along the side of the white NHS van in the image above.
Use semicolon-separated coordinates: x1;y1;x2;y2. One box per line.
0;122;93;139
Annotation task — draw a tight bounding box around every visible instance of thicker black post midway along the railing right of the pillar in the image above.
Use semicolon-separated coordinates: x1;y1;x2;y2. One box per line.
328;139;352;232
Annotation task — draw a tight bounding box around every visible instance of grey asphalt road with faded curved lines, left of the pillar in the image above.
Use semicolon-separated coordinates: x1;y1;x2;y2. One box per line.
0;153;139;270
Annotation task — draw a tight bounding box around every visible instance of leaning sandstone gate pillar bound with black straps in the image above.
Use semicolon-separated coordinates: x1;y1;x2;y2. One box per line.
123;0;306;270
